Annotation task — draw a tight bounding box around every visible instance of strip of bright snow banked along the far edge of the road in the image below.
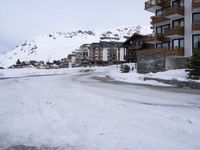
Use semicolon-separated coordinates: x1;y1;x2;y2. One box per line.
0;64;200;87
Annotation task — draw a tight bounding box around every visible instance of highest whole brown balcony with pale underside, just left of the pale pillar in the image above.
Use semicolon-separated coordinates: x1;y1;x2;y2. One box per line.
165;5;184;19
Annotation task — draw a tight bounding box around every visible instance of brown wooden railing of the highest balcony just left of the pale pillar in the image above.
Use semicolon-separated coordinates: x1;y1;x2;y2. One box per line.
165;5;184;17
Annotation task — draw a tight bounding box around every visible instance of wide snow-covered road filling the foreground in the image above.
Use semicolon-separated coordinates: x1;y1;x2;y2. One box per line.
0;73;200;150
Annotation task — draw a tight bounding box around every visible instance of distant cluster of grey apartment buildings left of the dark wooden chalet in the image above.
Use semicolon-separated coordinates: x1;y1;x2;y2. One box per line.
68;41;126;67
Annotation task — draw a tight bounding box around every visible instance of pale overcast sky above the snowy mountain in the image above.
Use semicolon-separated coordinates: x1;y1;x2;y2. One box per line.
0;0;152;53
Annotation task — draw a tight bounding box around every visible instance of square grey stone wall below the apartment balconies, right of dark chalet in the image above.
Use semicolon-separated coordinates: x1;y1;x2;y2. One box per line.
137;51;166;74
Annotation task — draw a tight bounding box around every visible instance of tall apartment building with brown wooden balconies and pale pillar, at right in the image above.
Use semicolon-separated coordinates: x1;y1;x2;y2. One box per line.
145;0;200;69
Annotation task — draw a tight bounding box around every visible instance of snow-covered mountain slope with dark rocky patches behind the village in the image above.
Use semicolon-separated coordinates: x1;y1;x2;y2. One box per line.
0;26;151;68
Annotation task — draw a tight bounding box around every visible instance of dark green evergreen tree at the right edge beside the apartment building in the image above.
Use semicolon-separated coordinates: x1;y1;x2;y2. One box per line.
187;50;200;80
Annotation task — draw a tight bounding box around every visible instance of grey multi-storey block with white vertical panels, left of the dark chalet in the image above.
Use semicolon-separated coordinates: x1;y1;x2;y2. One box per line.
89;41;126;65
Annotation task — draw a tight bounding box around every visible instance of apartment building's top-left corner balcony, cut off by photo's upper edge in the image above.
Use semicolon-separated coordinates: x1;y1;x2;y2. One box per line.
145;0;170;13
